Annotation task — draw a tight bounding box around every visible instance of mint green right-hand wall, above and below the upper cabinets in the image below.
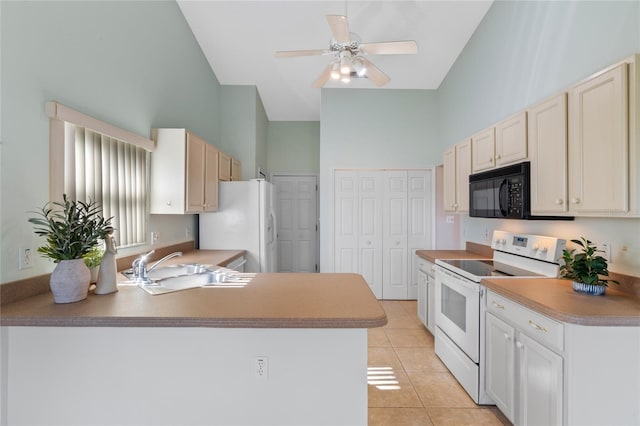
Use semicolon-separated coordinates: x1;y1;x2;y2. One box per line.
438;1;640;274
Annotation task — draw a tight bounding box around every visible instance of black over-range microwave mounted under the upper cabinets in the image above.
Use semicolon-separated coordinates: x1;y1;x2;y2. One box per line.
469;161;573;220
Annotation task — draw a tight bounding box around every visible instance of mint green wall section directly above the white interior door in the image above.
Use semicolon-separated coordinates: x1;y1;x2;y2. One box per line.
267;121;320;173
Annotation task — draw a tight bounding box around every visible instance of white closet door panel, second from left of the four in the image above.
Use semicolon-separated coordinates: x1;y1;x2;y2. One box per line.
354;170;383;299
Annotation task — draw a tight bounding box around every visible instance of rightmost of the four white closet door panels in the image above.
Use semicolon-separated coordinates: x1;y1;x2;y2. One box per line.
407;170;434;299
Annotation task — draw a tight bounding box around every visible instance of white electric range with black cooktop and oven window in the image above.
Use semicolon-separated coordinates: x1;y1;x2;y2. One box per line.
434;231;566;404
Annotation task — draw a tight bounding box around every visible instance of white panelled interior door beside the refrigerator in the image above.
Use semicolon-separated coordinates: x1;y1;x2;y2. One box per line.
271;175;318;272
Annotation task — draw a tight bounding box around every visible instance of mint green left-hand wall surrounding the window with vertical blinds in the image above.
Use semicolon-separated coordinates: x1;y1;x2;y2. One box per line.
0;1;220;283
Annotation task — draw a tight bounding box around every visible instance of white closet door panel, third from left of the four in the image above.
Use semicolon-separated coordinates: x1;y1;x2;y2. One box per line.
382;171;408;300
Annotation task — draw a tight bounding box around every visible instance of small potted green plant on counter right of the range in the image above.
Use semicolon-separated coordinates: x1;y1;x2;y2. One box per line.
560;237;619;296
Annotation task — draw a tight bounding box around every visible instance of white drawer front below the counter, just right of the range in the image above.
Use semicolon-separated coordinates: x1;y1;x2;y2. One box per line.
487;290;564;352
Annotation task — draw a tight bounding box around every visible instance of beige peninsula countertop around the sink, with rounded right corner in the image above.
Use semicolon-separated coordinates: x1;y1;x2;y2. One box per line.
0;250;387;328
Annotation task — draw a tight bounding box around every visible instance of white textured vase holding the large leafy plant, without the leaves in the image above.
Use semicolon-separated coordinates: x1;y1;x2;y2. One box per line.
49;259;91;303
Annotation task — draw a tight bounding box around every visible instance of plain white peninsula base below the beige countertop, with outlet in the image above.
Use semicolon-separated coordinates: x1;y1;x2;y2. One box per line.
1;327;367;426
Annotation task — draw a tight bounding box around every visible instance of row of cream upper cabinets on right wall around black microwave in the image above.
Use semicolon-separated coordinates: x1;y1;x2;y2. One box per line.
444;54;640;217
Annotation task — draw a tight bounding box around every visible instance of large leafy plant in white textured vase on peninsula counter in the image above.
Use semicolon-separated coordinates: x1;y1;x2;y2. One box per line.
28;194;113;303
